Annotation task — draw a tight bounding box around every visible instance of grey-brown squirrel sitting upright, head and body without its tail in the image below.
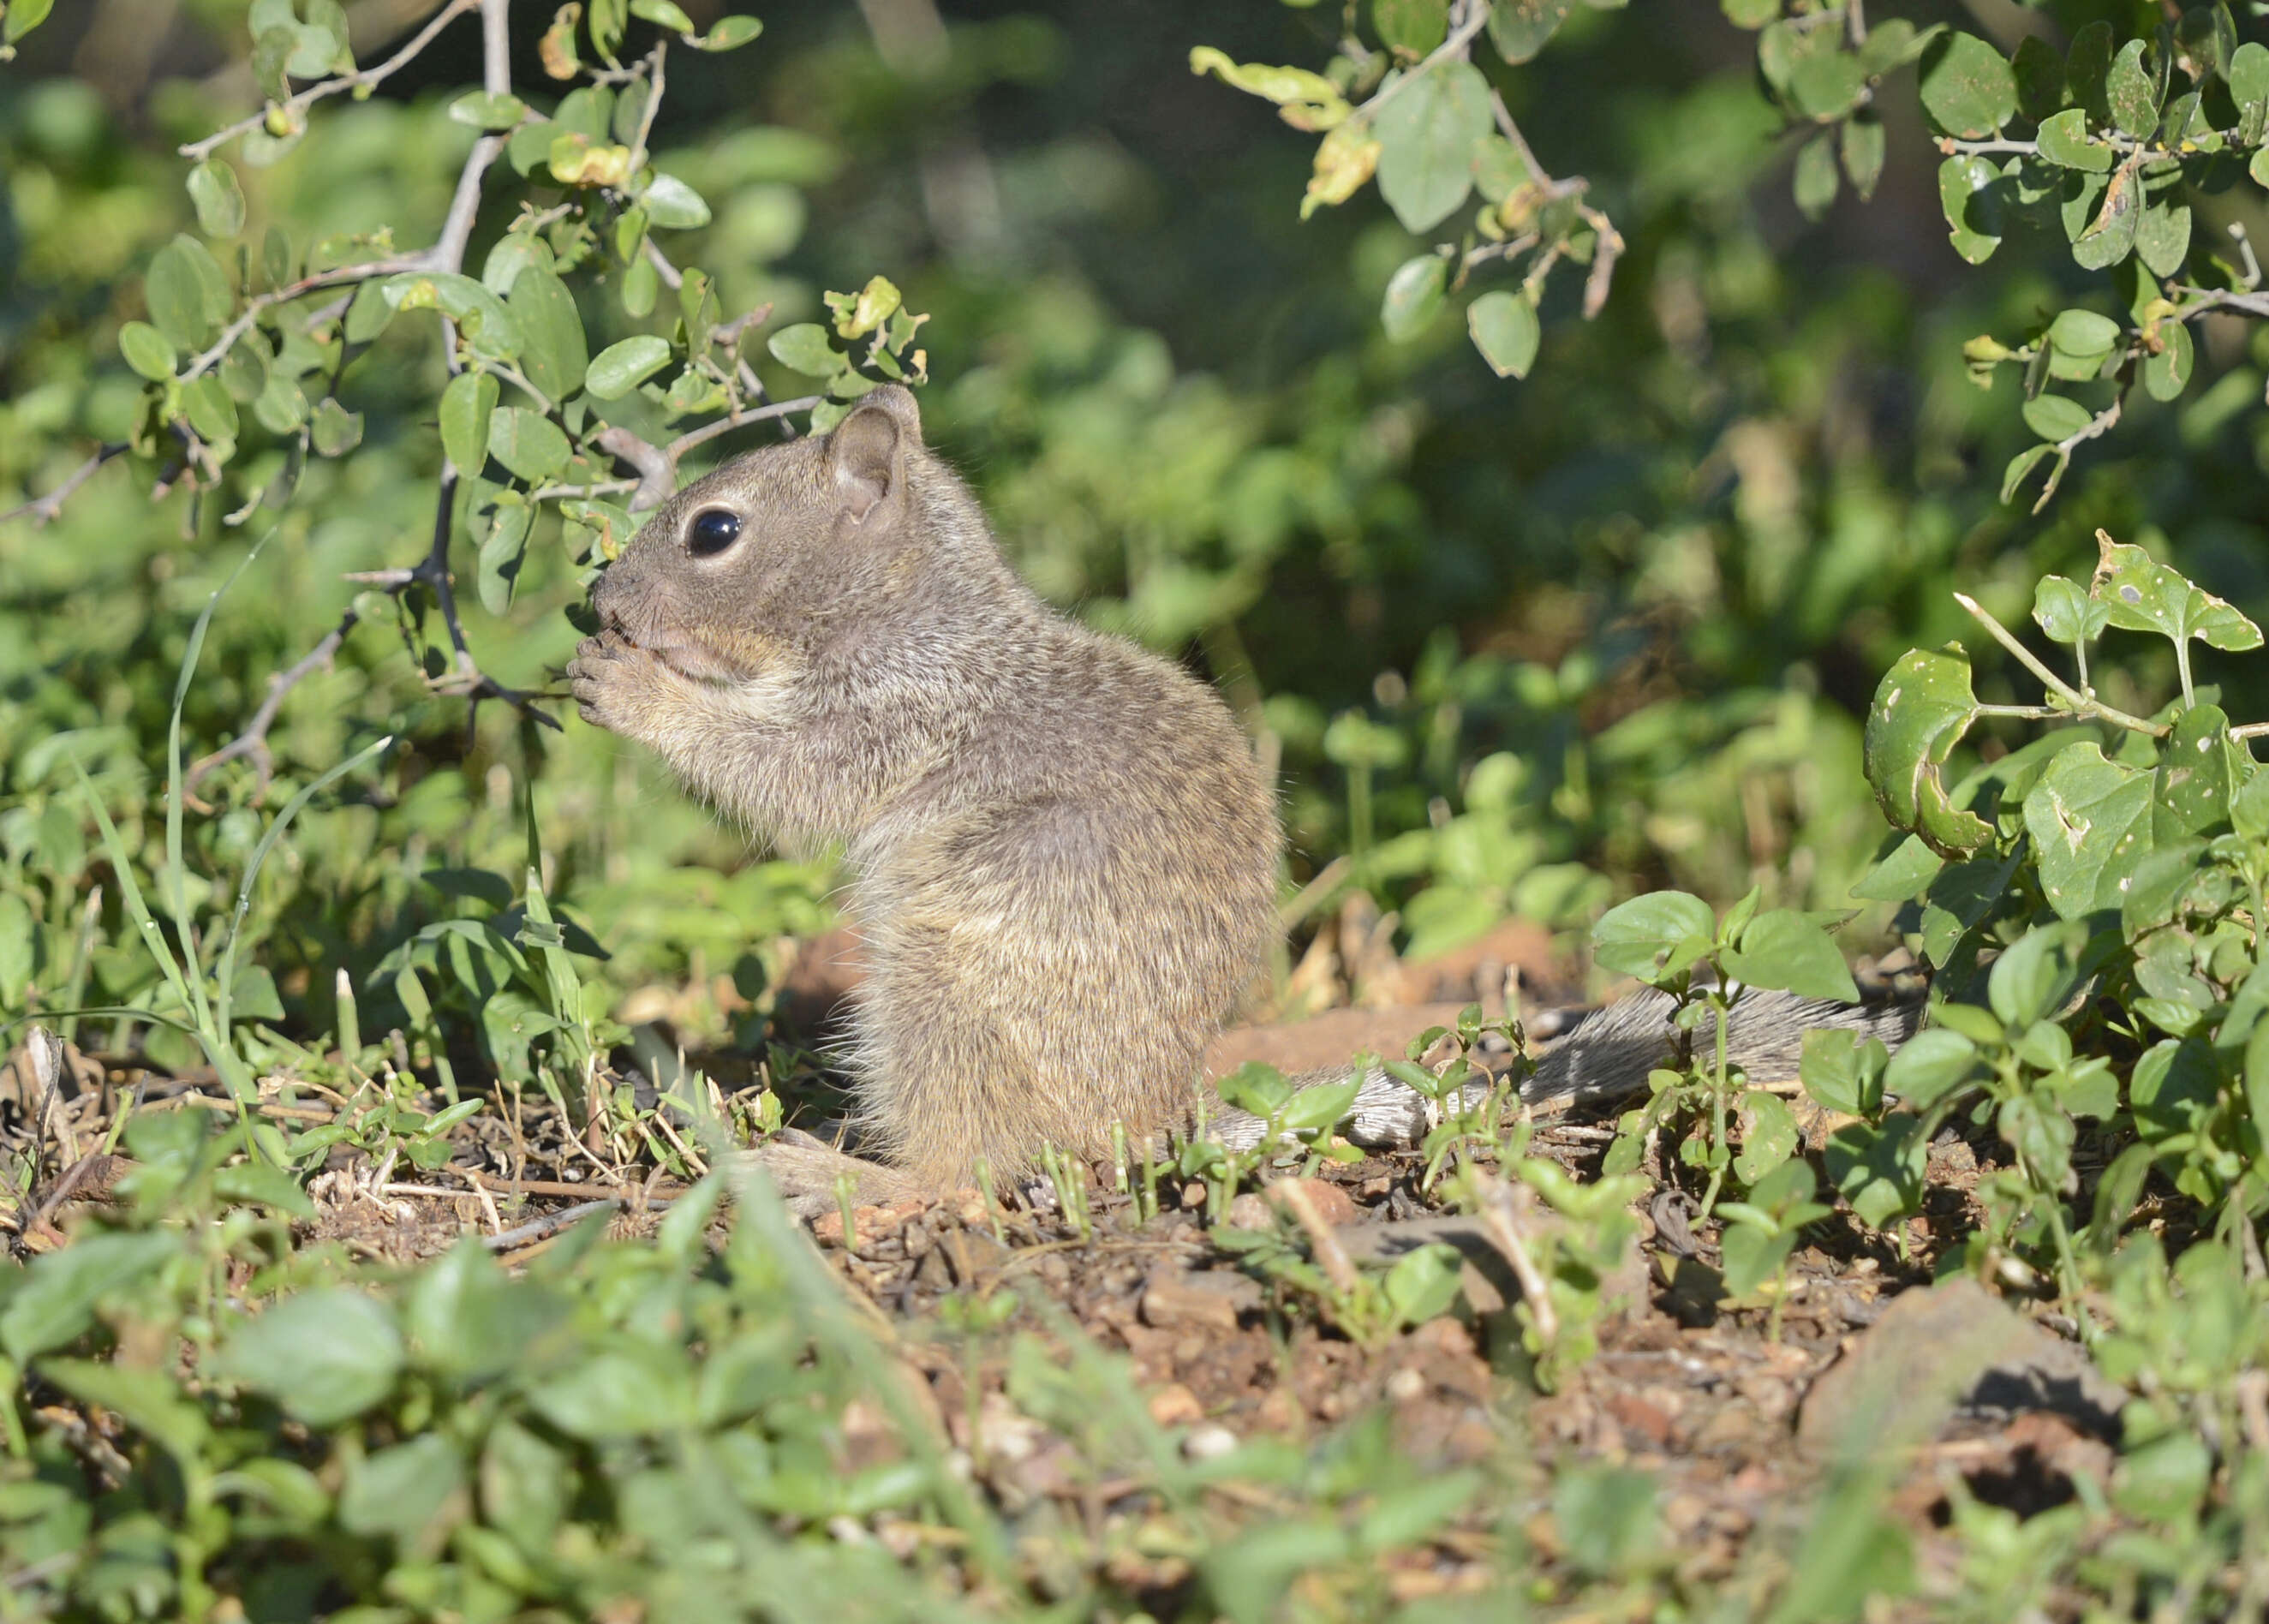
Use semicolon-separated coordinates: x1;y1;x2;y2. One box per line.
570;388;1280;1196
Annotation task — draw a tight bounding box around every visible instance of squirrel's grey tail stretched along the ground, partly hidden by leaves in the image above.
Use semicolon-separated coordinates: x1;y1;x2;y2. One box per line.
1209;989;1922;1150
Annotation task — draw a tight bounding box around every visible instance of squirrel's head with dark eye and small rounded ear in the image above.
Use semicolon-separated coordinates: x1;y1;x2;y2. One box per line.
592;384;962;683
